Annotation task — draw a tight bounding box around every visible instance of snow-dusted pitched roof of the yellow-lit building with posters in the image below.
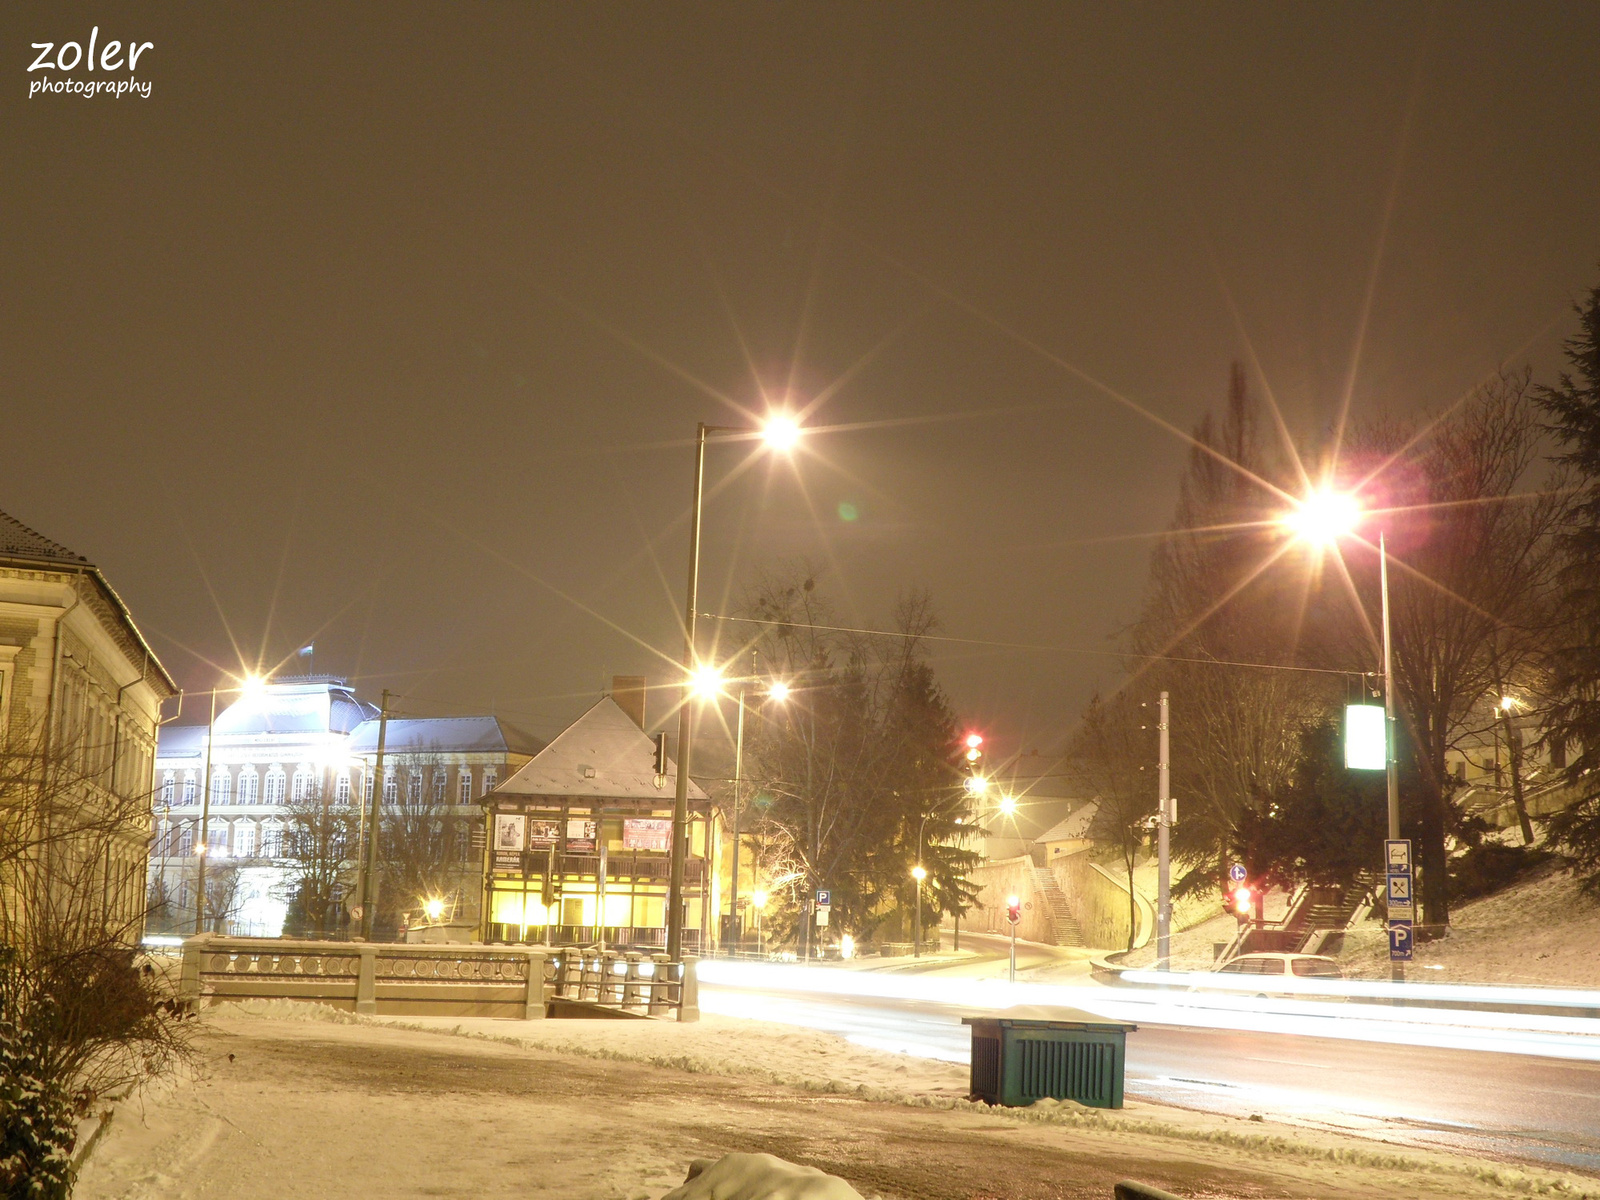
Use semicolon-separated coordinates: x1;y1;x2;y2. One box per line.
494;696;707;803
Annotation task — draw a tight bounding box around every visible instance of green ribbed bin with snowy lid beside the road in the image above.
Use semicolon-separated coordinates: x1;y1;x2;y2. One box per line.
962;1008;1138;1109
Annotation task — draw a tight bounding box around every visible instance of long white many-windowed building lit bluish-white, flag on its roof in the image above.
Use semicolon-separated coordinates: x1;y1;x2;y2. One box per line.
150;675;542;938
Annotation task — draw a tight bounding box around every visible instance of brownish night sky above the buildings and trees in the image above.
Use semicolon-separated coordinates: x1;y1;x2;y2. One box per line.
0;3;1600;749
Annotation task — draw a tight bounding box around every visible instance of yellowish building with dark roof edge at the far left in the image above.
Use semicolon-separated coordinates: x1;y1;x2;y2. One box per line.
0;512;178;942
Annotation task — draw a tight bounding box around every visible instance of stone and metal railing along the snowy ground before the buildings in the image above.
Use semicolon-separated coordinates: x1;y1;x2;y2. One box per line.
179;933;699;1021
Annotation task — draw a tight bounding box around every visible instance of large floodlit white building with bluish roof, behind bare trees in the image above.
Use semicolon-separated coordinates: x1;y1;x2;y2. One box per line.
149;675;541;938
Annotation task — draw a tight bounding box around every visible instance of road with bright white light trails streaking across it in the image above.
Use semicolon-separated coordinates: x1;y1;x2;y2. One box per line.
699;960;1600;1171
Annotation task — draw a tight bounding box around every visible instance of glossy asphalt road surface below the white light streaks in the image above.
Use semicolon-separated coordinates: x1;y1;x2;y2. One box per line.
701;972;1600;1171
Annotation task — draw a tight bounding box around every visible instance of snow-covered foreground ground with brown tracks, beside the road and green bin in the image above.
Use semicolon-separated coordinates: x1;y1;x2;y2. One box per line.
78;1002;1600;1200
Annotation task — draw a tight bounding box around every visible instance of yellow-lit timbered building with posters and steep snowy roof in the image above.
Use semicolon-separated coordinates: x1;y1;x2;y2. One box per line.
482;690;720;950
